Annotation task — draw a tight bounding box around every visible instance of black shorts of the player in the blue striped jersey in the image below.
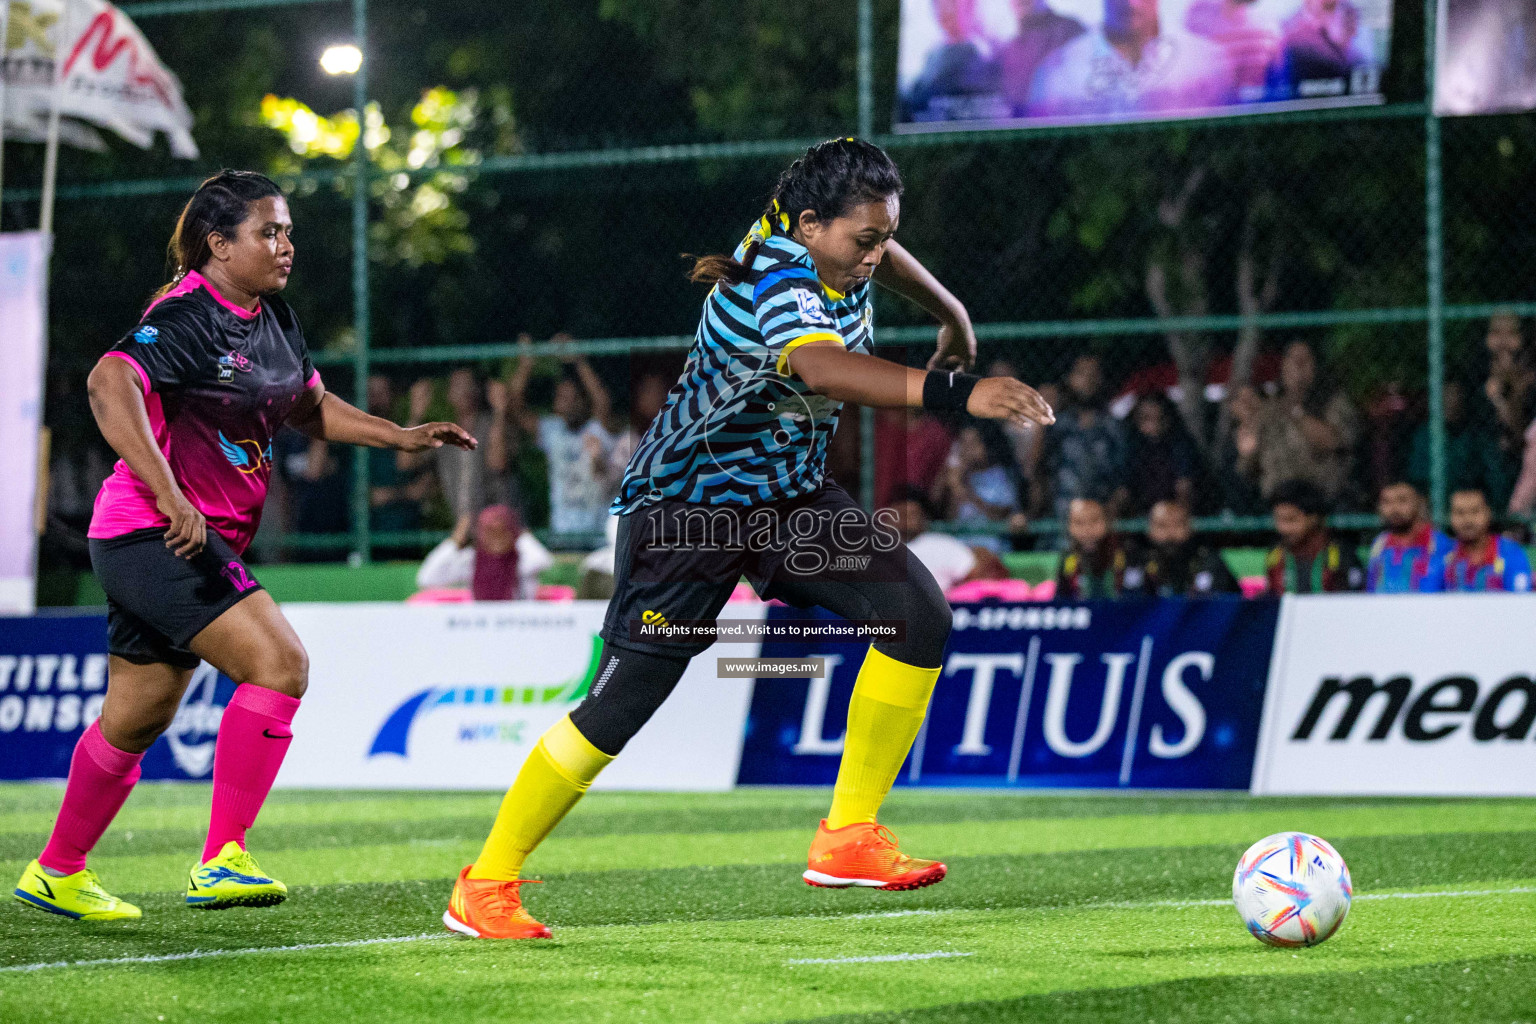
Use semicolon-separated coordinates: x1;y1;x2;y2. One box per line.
601;481;926;657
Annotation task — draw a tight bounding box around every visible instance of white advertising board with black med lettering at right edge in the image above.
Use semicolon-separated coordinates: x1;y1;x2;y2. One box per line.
1253;594;1536;797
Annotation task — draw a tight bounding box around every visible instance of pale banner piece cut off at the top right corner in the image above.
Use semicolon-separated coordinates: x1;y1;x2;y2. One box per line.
1435;0;1536;117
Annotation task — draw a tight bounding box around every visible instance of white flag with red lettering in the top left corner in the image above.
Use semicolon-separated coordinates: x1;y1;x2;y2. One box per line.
0;0;197;158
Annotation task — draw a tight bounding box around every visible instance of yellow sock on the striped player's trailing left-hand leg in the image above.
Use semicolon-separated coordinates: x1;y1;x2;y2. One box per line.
470;717;613;881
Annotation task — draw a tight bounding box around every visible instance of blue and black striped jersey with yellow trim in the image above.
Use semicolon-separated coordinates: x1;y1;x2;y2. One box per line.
611;216;872;514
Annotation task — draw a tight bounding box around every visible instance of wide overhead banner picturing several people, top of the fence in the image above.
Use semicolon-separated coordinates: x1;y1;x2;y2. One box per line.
895;0;1392;132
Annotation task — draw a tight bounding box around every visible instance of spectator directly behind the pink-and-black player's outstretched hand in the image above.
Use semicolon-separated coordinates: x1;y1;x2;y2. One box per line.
417;367;518;520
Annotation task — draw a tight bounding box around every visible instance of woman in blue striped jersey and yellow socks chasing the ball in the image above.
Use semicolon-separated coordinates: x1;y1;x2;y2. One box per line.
444;138;1054;938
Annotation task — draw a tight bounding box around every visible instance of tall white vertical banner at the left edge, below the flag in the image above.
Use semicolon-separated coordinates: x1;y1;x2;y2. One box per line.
0;231;48;616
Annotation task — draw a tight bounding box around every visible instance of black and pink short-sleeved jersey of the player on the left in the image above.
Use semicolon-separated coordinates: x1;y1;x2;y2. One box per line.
89;270;319;554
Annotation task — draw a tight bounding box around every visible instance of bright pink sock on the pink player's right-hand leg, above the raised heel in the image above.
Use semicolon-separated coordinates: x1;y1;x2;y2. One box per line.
203;683;298;864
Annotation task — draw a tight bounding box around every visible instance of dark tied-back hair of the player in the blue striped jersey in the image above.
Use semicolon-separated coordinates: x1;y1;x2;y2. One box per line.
684;135;903;284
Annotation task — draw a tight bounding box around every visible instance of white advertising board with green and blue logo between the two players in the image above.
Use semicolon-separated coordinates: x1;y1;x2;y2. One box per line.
276;602;763;789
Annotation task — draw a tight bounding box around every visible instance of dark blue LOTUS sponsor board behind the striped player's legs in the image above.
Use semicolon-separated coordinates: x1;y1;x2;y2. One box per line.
737;597;1279;789
